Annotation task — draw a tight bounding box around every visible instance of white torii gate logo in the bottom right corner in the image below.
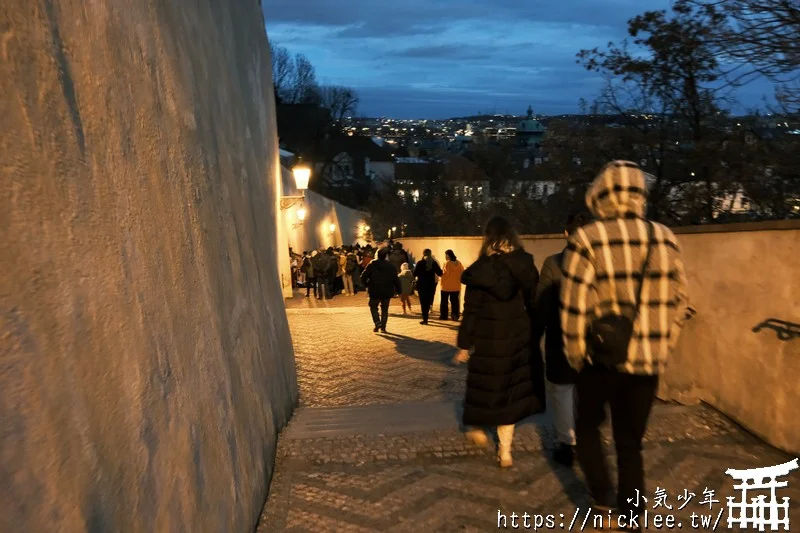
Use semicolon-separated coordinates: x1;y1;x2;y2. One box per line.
725;459;798;531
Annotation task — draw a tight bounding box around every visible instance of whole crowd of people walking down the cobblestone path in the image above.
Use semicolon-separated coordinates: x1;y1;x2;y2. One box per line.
290;161;690;530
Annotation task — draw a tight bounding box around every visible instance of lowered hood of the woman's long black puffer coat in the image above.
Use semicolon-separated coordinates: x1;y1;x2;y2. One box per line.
461;250;534;301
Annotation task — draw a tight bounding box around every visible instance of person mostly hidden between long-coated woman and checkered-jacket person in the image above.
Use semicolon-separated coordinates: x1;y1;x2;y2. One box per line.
533;213;591;467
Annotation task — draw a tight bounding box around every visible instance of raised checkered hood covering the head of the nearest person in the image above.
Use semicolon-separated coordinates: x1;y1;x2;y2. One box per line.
586;161;647;219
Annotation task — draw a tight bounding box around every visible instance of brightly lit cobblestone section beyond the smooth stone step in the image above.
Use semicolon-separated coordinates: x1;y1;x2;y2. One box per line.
287;294;465;407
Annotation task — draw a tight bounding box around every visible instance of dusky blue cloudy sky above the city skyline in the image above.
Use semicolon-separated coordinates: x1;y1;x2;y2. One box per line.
263;0;772;118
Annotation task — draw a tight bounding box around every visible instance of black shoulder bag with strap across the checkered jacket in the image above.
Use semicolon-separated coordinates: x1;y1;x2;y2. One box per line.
586;221;653;367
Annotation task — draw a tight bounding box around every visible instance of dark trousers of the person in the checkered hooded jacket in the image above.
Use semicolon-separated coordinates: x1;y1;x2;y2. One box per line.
575;365;658;514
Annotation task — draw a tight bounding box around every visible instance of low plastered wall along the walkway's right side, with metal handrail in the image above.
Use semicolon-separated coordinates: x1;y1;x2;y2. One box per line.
401;221;800;453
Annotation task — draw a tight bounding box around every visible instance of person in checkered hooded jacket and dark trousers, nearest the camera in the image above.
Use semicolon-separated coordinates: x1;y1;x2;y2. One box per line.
560;161;688;529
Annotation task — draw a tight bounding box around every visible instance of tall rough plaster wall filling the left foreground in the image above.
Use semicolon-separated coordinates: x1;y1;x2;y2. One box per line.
0;0;297;533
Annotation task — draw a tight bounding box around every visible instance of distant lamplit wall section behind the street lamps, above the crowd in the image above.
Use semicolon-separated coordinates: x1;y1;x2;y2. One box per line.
282;167;367;253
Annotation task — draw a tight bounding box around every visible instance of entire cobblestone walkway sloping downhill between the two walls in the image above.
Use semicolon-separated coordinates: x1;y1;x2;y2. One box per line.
258;296;800;533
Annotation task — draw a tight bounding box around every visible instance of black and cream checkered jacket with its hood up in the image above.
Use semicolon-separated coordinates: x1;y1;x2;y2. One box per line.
561;161;688;375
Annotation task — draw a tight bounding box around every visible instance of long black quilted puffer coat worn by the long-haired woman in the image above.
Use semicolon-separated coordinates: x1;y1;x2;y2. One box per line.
458;250;545;426
